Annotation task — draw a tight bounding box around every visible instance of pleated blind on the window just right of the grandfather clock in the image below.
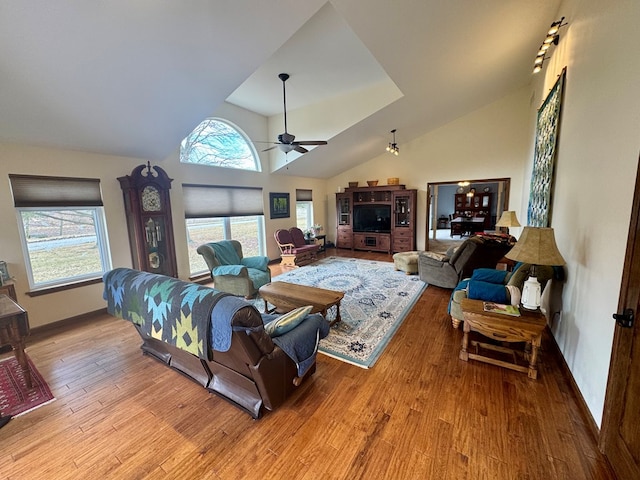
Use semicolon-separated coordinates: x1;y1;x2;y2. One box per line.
182;184;264;218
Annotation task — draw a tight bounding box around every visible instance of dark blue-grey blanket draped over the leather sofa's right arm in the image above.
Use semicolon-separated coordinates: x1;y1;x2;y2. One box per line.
262;313;329;377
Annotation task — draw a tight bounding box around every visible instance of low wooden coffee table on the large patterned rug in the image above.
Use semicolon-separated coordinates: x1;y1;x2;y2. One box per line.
258;282;344;326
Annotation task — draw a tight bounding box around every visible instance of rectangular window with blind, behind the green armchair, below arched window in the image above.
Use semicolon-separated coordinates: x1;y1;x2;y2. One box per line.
182;184;266;276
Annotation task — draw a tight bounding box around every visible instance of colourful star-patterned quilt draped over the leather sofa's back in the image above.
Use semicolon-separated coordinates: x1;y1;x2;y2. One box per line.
103;268;231;360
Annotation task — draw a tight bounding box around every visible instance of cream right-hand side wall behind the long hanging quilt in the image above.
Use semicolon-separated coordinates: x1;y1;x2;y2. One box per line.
522;0;640;424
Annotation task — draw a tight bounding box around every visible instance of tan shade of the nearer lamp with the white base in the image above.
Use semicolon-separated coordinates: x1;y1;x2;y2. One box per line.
505;227;566;265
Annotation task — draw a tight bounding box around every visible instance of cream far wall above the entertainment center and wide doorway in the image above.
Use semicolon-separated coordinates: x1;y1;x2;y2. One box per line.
327;88;532;249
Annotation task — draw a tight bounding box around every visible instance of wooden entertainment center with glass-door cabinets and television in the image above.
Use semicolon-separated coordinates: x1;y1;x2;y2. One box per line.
336;185;417;254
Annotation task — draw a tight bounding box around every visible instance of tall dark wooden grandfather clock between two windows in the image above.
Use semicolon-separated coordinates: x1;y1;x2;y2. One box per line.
118;162;178;277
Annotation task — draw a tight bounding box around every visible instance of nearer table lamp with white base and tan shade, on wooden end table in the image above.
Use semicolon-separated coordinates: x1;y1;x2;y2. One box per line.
505;227;566;310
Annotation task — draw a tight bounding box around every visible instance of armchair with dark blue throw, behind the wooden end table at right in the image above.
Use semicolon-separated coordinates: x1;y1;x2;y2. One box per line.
449;263;564;328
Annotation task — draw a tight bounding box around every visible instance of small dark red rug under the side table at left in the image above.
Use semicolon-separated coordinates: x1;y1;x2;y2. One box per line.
0;356;55;417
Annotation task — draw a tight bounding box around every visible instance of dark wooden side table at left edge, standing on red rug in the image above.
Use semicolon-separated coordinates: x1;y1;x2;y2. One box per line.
0;295;31;388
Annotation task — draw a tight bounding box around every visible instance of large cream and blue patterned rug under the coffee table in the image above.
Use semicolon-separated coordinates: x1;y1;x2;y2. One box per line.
256;257;426;368
